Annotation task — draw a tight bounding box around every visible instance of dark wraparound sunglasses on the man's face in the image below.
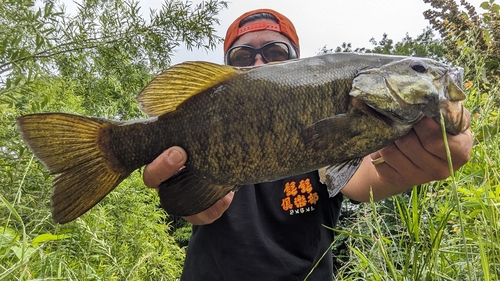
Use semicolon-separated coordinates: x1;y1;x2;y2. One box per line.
225;41;297;66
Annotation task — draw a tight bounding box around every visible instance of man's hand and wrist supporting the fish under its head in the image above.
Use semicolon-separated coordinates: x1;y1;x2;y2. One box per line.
341;111;472;202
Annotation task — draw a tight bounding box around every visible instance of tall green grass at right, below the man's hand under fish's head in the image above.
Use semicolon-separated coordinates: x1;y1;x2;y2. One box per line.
335;58;500;280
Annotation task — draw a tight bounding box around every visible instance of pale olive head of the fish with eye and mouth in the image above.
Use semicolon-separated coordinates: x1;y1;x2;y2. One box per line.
350;57;469;134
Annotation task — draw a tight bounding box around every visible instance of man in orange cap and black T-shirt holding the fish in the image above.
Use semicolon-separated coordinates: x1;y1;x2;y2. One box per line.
144;9;472;280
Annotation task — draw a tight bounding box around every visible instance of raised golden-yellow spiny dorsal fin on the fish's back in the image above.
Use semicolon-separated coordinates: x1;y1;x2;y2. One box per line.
137;61;239;117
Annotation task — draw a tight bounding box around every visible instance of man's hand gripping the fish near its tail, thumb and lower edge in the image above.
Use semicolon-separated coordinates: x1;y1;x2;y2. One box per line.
143;146;234;225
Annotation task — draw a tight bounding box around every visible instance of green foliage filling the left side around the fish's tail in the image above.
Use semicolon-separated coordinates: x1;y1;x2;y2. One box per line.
0;0;226;280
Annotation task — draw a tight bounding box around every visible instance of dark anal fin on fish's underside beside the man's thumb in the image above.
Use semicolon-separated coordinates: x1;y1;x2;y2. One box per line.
159;168;240;216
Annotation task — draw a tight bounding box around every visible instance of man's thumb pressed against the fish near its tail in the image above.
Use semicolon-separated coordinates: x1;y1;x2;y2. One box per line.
142;146;187;188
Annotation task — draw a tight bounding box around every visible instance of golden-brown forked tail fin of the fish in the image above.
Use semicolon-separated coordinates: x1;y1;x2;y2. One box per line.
17;113;129;223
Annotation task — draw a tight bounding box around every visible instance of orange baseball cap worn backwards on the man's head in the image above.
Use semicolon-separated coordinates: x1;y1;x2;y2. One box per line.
224;9;299;53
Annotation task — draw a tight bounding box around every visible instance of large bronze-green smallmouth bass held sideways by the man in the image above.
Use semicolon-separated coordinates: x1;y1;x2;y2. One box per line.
17;53;469;223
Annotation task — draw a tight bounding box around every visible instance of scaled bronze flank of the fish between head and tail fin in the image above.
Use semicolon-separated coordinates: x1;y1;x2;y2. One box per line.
108;55;390;184
